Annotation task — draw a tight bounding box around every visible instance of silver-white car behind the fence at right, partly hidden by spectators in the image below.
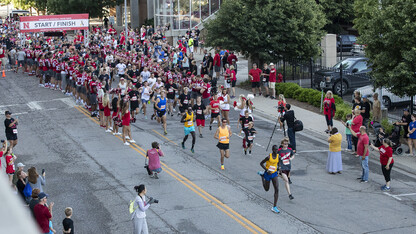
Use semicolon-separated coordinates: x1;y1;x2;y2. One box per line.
352;85;416;109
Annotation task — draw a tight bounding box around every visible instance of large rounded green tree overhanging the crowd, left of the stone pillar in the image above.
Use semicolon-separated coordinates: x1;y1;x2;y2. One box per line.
204;0;326;61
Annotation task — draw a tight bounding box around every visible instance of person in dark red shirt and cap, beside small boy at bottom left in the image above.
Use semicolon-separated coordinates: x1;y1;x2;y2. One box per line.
33;193;54;234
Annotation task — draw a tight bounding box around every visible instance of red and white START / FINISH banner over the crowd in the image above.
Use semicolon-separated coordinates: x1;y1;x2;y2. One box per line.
20;14;89;32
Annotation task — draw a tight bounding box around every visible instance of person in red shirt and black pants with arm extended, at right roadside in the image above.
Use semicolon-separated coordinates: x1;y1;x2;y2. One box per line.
370;139;394;191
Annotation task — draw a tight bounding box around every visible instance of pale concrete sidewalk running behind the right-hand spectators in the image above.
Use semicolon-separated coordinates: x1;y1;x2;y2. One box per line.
195;50;416;175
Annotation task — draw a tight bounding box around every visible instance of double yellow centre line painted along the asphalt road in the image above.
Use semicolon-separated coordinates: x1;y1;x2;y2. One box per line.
75;106;267;233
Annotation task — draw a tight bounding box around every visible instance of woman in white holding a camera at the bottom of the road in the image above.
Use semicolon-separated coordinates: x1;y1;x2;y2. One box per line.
131;184;159;234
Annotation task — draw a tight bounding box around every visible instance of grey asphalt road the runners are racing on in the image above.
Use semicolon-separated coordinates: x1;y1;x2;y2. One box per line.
0;72;416;233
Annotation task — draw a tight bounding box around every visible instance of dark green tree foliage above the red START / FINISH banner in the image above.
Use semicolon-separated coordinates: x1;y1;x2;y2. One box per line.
47;0;122;18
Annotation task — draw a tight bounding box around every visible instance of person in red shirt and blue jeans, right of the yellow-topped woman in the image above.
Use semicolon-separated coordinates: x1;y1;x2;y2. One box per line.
351;126;370;183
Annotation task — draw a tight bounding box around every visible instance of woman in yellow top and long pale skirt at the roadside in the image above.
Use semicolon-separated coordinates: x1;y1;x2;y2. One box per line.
326;128;342;175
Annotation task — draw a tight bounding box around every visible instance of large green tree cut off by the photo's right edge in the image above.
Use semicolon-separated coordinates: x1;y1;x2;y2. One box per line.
354;0;416;96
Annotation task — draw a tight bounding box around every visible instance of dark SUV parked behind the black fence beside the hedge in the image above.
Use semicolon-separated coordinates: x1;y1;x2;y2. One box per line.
313;57;371;95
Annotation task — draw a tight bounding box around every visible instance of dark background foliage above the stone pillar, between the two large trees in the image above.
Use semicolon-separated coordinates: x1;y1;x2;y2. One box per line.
316;0;354;34
